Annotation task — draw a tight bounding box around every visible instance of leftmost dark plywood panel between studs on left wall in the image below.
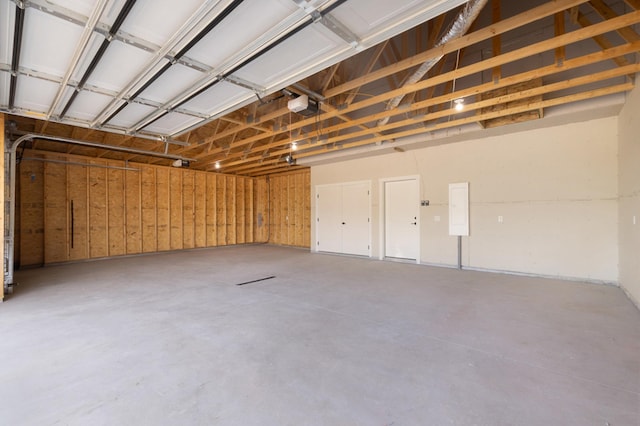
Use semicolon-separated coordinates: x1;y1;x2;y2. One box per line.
16;161;44;266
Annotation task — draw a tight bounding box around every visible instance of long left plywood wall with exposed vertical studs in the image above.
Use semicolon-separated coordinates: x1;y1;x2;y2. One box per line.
17;150;270;266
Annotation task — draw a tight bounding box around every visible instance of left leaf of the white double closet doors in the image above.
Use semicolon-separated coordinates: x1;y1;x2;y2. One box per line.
316;185;342;253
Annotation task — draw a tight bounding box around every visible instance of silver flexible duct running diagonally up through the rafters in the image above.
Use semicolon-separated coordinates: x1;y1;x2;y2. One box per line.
376;0;488;126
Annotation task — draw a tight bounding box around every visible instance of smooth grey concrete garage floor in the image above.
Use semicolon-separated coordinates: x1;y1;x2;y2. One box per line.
0;246;640;426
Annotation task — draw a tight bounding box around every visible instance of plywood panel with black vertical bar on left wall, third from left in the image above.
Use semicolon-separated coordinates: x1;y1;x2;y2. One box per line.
66;165;89;260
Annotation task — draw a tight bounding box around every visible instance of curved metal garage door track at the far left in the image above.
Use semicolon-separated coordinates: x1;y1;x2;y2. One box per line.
4;133;197;293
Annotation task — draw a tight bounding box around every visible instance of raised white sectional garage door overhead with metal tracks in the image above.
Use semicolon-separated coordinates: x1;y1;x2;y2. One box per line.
0;0;465;139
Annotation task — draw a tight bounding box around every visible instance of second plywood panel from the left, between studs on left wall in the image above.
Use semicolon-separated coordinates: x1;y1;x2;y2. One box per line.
44;163;69;263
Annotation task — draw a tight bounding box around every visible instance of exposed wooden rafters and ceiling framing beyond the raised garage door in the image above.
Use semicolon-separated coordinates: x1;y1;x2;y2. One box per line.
11;0;640;176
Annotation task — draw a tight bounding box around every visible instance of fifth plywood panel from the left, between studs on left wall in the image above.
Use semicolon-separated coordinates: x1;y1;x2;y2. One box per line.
107;169;126;256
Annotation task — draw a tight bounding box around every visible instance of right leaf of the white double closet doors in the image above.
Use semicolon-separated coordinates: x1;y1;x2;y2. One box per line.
342;182;371;256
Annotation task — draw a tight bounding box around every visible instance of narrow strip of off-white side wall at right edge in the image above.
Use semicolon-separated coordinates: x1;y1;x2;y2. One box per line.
618;80;640;307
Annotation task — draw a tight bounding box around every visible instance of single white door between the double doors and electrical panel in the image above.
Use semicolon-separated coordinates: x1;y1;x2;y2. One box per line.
384;179;420;260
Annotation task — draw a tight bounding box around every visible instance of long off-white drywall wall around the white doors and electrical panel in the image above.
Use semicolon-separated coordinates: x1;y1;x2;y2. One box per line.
311;117;620;282
